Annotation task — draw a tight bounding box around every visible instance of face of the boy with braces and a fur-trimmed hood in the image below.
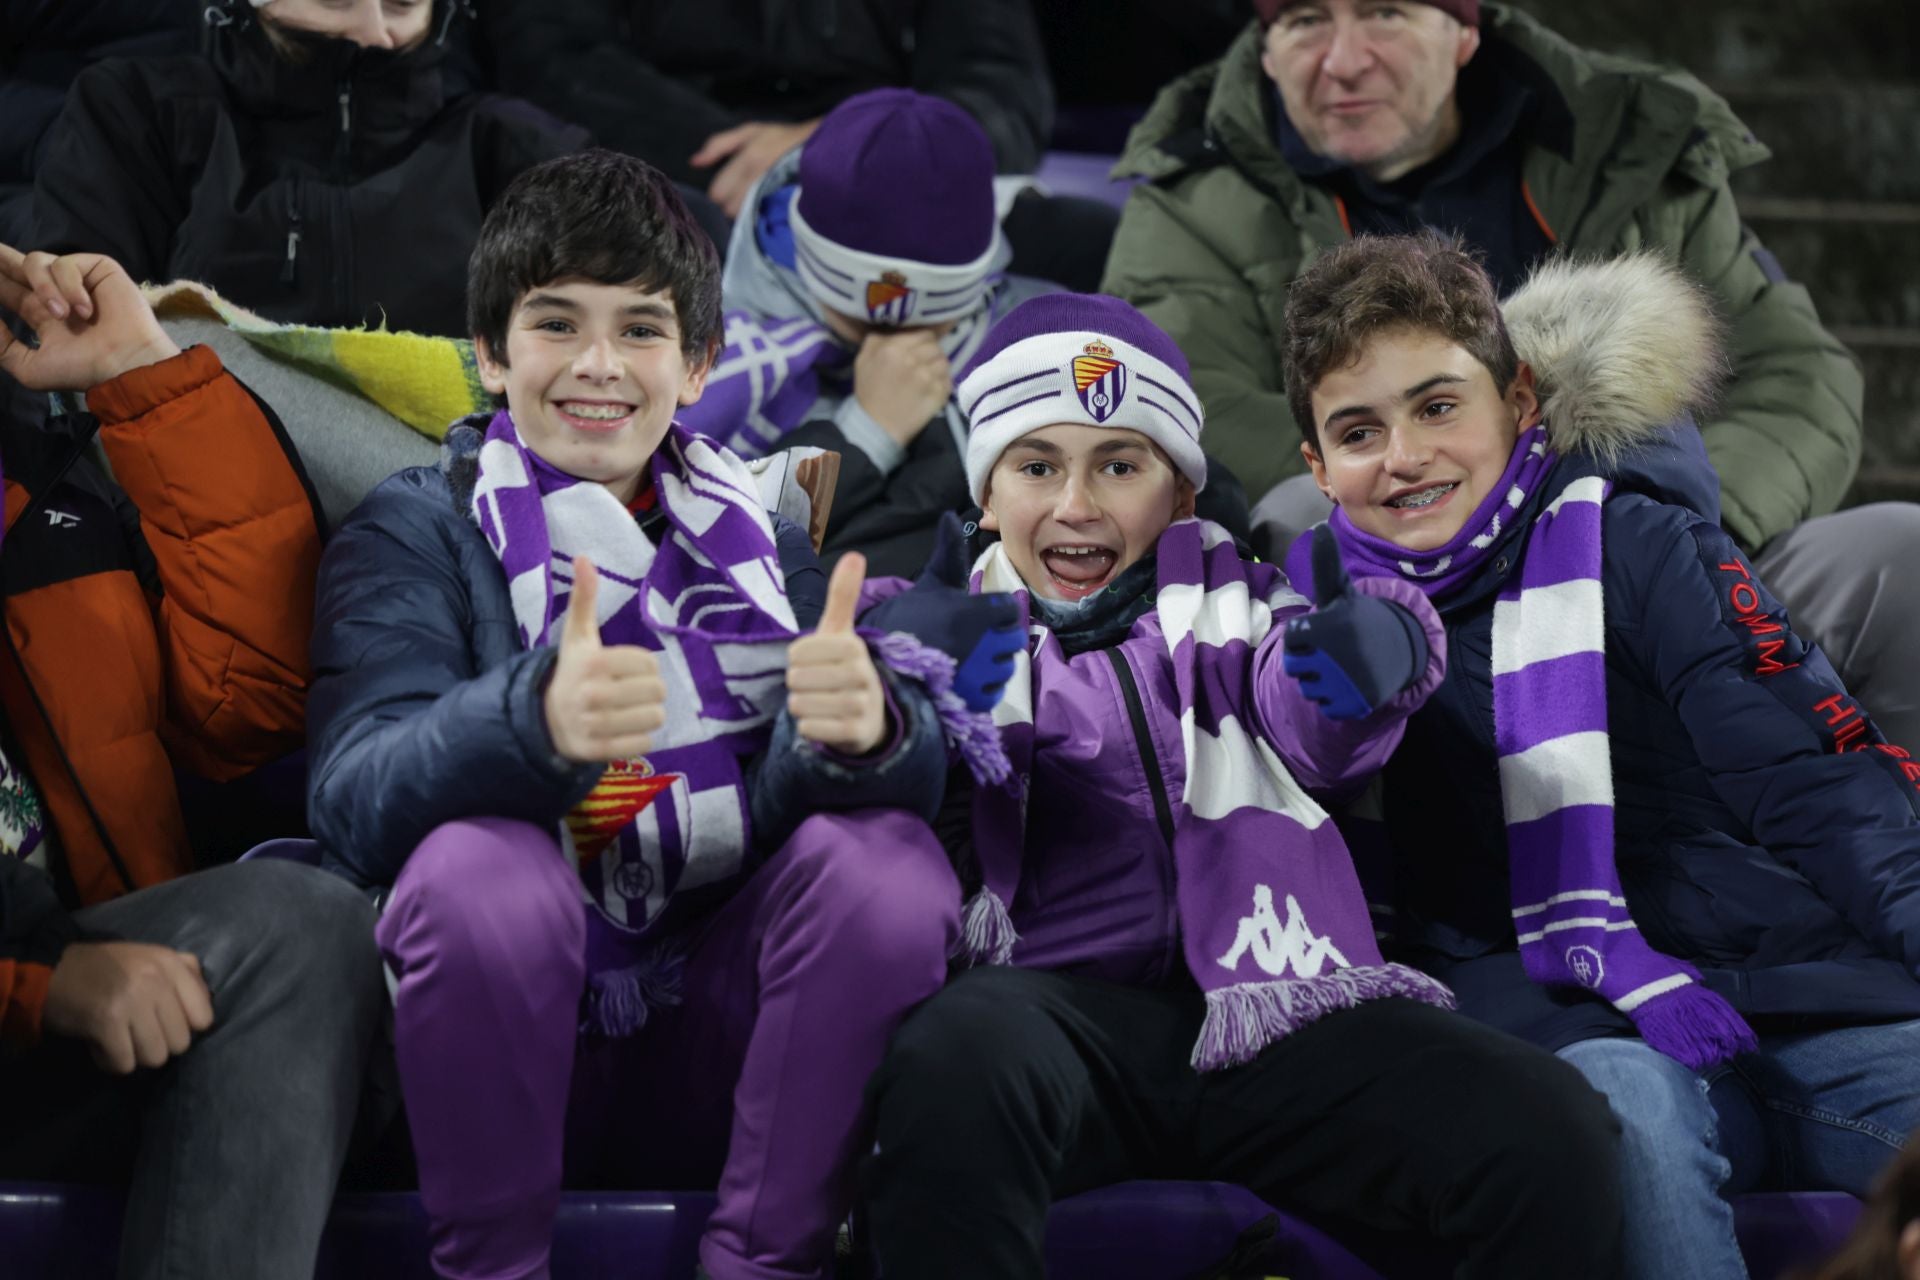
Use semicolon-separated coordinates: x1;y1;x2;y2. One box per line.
1300;328;1540;551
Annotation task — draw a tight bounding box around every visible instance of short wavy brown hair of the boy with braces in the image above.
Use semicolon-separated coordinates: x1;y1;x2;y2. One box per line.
1281;230;1521;451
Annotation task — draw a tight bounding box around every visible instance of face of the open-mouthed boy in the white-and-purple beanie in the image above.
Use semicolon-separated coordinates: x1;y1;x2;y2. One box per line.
979;422;1194;601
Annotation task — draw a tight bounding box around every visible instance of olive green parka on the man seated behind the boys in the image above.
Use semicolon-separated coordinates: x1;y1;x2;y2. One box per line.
1104;4;1862;551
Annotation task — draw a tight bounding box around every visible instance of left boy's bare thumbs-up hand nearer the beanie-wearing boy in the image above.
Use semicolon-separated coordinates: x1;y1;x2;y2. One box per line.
787;551;887;756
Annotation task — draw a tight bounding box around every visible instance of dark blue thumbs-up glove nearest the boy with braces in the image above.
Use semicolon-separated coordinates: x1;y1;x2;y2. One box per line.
1281;524;1427;720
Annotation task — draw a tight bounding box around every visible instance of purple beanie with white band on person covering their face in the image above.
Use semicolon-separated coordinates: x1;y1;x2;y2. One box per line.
791;88;1006;326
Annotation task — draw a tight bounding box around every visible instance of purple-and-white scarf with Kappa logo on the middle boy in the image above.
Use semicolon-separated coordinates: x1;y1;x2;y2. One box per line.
962;520;1453;1071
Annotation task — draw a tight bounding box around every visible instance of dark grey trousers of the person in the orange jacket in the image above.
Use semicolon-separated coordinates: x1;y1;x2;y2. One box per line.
0;860;386;1280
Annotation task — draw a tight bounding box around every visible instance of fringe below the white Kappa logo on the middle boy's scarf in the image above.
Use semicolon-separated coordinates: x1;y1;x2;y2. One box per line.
1192;963;1453;1071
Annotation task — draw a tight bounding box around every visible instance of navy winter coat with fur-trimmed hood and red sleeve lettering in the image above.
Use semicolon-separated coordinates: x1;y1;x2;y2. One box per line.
1288;263;1920;1050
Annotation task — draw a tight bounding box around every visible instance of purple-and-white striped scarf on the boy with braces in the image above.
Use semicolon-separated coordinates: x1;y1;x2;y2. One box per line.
1332;426;1755;1071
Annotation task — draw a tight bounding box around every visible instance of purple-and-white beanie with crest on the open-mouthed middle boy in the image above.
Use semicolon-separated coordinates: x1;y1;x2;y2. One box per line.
956;294;1206;503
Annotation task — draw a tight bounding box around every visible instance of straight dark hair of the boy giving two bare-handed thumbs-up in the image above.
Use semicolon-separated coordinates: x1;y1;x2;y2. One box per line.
467;148;720;365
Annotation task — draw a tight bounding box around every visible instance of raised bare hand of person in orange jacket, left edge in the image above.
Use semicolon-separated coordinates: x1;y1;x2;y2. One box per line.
0;244;180;391
